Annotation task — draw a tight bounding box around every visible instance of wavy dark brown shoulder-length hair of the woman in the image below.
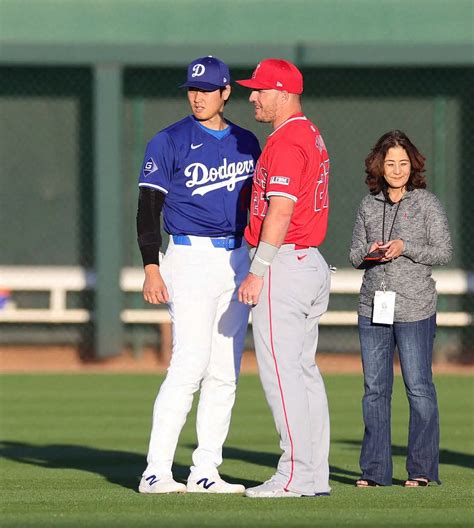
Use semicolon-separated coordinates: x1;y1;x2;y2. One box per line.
365;130;426;194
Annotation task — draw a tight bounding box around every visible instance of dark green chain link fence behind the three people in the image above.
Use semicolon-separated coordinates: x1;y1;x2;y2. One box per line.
0;62;474;355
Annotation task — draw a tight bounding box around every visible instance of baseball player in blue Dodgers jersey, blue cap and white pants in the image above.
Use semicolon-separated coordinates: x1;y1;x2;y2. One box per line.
137;57;260;493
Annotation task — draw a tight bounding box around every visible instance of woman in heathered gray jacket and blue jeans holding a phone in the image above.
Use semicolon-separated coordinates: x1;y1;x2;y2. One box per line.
350;130;452;487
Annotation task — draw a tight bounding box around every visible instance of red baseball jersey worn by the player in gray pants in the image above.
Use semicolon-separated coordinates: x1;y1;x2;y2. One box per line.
245;113;329;246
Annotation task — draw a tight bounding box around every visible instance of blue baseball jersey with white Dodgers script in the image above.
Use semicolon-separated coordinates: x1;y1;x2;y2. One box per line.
138;116;260;236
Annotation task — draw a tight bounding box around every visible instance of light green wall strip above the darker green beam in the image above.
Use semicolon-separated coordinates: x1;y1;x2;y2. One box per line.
0;0;473;46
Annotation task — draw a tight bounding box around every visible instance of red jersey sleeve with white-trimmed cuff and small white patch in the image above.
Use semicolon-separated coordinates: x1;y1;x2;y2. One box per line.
266;142;307;202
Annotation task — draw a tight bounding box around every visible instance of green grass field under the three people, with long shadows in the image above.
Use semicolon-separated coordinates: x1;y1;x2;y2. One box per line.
0;374;474;528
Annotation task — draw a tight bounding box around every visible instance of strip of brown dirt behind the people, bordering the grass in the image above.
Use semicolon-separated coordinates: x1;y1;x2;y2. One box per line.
0;346;474;375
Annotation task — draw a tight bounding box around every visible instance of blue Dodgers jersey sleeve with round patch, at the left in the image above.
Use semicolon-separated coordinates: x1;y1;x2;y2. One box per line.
138;132;175;194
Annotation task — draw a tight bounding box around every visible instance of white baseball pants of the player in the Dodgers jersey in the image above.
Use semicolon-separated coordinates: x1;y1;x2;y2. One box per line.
143;237;250;477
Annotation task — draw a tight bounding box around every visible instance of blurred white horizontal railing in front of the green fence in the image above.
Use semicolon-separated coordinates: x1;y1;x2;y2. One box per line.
0;266;474;327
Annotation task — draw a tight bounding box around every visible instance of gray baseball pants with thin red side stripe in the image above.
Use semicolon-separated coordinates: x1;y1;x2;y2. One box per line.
251;244;330;495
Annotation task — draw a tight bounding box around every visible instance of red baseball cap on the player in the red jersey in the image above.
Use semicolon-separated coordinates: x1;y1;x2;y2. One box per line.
236;59;303;94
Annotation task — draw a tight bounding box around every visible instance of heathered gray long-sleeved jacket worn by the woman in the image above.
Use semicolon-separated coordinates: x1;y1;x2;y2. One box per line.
349;189;453;322
